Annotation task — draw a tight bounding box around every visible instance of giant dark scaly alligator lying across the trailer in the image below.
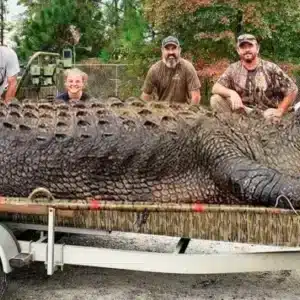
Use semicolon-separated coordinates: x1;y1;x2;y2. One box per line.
0;98;300;208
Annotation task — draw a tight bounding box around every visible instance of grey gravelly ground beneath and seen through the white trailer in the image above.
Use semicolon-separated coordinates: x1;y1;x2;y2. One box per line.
4;233;300;300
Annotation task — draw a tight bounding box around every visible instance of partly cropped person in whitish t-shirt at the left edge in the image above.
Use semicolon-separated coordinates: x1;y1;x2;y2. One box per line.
0;46;20;96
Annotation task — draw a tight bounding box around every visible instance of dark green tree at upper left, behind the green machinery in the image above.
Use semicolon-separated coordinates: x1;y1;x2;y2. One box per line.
18;0;104;57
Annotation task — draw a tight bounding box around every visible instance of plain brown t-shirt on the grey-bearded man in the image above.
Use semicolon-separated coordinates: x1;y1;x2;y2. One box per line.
142;58;201;103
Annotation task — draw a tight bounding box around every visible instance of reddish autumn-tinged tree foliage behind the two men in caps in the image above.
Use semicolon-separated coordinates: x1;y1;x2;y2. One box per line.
145;0;300;60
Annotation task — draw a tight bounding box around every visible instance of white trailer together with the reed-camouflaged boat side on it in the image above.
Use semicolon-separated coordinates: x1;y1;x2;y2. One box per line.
0;189;300;294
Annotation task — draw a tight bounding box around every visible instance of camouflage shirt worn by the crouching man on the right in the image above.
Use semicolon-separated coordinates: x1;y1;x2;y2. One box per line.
217;59;297;109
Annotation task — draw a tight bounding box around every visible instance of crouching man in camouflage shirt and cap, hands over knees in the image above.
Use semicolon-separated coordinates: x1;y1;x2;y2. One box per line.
210;34;298;121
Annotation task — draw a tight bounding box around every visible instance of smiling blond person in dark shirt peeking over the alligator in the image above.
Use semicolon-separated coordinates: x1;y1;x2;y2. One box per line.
56;68;90;103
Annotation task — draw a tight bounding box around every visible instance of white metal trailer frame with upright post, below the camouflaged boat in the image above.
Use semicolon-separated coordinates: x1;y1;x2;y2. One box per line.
0;207;300;296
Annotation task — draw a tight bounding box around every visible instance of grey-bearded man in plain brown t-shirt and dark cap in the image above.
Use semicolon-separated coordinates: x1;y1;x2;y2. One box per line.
141;36;201;104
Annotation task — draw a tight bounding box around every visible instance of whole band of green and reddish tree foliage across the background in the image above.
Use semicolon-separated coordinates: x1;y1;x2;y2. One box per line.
15;0;300;62
